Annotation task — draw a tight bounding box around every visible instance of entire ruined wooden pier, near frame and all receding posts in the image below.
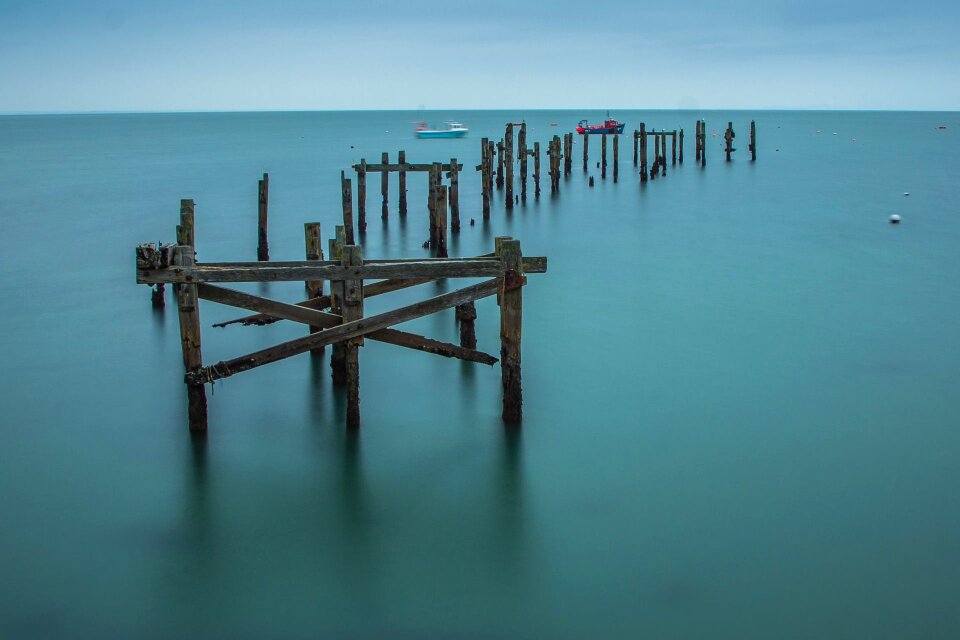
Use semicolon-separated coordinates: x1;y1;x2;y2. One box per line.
136;119;757;431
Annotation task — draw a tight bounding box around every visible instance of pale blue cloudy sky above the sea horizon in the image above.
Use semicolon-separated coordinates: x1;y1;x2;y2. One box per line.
0;0;960;113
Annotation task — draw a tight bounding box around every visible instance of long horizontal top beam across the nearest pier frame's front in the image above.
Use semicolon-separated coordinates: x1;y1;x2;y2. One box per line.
137;257;547;284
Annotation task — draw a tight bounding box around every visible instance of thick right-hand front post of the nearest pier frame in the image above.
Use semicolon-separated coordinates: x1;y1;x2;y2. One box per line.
497;238;524;423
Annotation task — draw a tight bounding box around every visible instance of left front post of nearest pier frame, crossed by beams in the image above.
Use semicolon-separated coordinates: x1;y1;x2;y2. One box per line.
173;245;207;432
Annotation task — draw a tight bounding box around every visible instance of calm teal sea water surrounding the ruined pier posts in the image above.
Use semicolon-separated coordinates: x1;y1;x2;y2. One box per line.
0;111;960;639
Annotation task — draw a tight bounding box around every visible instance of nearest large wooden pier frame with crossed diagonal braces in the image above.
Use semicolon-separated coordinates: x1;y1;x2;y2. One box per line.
136;200;547;431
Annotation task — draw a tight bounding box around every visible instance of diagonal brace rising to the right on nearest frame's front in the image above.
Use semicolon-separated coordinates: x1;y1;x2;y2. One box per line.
186;278;500;384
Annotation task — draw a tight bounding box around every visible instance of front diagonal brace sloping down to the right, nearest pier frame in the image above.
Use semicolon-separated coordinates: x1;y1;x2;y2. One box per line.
197;284;497;365
